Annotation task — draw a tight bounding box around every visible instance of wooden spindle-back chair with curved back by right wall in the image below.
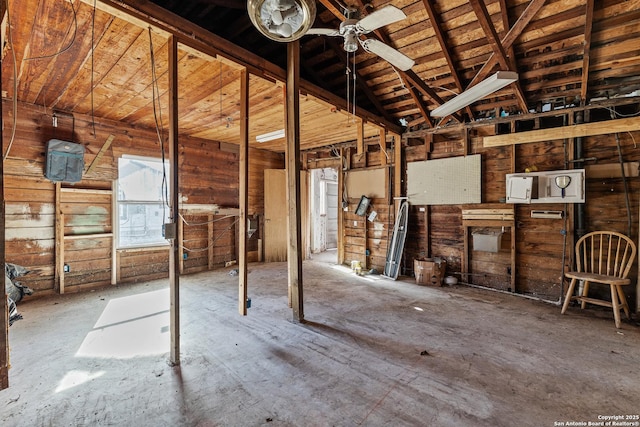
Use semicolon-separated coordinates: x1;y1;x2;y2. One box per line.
562;231;636;328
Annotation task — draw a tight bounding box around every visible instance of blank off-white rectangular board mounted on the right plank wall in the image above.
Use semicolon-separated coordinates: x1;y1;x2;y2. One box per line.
407;154;482;205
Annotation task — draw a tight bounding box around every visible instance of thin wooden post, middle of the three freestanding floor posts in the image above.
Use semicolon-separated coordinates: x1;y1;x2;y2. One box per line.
237;70;249;316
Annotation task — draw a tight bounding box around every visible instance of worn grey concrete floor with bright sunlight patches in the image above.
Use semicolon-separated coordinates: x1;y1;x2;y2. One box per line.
0;256;640;427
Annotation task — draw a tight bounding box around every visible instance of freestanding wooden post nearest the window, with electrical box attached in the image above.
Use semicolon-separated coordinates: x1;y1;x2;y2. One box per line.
167;36;180;365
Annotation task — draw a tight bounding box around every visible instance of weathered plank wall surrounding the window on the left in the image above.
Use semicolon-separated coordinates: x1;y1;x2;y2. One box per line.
3;103;284;292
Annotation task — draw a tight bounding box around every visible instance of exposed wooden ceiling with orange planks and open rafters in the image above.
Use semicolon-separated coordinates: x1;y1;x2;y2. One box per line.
2;0;640;154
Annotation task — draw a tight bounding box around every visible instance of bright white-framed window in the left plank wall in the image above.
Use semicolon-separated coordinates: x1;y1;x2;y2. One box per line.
117;156;170;248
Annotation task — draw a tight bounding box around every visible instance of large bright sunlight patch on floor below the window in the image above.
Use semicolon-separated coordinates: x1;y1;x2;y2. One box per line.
76;289;170;359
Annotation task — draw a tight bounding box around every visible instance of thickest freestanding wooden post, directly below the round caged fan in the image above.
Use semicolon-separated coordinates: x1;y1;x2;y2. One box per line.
285;40;304;322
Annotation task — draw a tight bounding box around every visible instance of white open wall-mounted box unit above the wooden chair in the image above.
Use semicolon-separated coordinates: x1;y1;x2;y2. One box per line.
506;169;585;203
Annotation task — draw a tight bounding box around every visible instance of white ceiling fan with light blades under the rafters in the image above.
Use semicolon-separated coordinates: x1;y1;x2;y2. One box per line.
306;5;415;71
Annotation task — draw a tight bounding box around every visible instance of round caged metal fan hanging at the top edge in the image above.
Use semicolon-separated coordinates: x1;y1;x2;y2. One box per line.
247;0;316;42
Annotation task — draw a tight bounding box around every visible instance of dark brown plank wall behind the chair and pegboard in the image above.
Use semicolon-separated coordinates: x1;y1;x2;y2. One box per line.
404;110;640;306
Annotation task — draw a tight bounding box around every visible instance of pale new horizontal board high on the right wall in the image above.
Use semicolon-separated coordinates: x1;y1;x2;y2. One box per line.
482;117;640;147
